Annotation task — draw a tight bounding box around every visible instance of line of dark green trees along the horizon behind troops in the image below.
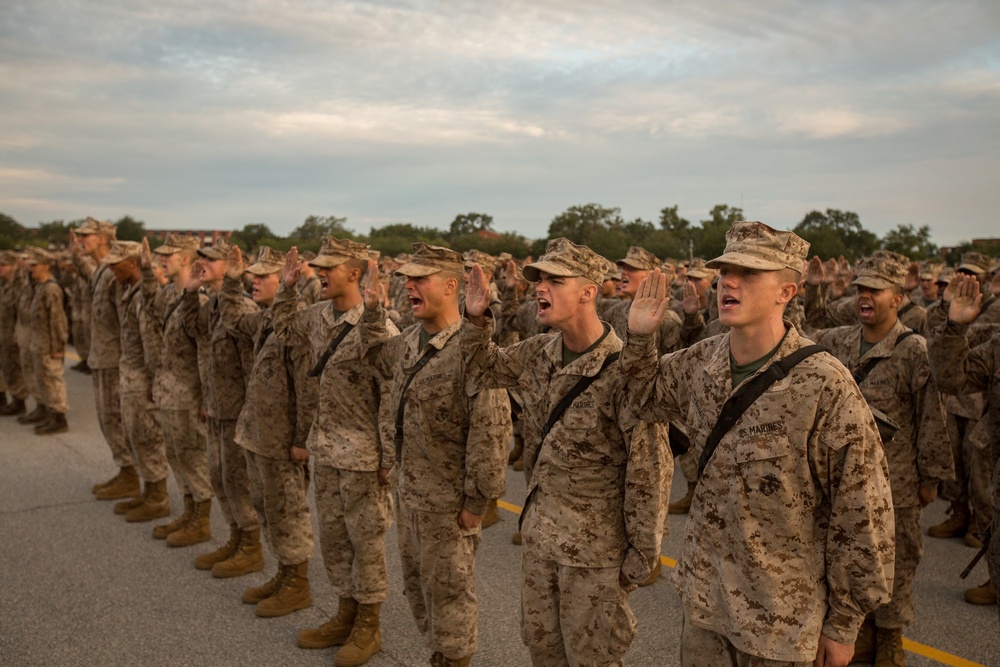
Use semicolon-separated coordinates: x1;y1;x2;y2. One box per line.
0;203;1000;263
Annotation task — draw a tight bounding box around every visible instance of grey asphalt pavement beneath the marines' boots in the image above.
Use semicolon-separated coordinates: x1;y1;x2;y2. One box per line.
0;359;1000;667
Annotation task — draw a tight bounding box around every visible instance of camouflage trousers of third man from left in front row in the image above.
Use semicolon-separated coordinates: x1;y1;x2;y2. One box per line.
159;410;212;503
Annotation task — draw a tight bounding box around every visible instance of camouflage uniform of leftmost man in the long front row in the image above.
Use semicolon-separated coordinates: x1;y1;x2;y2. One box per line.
73;230;134;468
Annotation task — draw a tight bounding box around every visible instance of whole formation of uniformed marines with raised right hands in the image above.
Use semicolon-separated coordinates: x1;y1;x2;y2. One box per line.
0;218;1000;667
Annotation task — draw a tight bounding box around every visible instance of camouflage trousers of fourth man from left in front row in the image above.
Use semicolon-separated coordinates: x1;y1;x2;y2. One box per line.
207;417;260;530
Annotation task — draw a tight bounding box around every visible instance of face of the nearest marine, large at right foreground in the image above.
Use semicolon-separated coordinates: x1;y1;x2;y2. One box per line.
716;264;795;328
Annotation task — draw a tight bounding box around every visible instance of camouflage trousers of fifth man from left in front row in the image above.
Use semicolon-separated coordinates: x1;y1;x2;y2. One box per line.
244;450;313;565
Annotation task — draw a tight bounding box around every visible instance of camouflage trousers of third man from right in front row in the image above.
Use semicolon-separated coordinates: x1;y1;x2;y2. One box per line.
396;497;482;660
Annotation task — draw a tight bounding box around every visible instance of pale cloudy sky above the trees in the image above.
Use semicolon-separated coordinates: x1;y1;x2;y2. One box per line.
0;0;1000;245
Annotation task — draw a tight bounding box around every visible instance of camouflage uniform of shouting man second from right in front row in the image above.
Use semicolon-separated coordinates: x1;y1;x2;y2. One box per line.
461;314;673;665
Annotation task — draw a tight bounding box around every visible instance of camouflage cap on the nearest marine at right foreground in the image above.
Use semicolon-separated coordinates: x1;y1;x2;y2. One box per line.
708;220;809;275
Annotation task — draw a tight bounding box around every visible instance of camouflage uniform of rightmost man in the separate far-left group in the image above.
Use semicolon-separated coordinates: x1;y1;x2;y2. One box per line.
28;266;69;415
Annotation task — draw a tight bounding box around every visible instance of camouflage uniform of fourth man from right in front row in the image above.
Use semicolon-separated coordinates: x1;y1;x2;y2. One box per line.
273;274;399;604
